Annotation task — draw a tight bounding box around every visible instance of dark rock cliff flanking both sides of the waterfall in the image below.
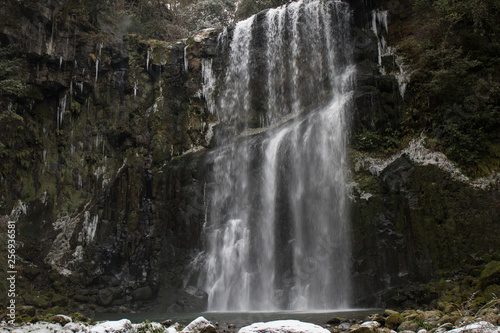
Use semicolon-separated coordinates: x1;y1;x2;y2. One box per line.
0;0;500;312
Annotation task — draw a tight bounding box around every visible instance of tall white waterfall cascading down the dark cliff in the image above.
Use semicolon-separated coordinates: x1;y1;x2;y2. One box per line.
200;0;354;311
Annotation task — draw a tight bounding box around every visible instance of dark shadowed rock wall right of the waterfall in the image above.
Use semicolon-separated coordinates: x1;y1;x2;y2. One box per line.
351;1;500;307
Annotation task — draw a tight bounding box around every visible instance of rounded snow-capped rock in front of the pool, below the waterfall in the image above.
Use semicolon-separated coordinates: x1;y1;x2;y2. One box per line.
238;320;330;333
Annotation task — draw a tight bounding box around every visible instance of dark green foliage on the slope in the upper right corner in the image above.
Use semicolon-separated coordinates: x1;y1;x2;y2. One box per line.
398;0;500;177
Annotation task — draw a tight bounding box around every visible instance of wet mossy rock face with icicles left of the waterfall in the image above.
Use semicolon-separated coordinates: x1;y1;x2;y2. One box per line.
0;1;218;311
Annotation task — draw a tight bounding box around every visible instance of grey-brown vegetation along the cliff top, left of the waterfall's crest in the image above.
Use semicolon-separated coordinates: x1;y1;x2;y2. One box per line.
67;0;291;41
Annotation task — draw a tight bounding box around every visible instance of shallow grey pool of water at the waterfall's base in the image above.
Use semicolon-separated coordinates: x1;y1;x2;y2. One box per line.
92;309;383;327
